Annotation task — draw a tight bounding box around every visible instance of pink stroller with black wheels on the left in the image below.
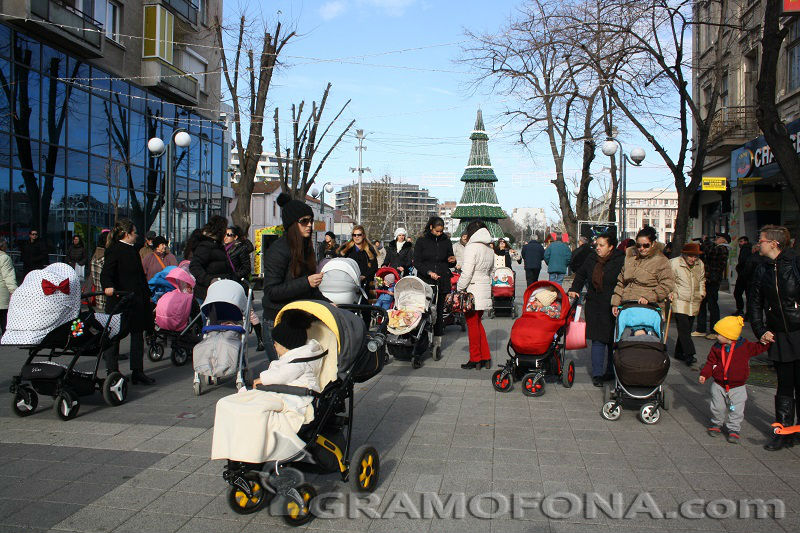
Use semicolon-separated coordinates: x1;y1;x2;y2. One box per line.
147;267;203;366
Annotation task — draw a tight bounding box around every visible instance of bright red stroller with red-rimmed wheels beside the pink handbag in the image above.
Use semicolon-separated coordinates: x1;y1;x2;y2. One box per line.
492;281;576;396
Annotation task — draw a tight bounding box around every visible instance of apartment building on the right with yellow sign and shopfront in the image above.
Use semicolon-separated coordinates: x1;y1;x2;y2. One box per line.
689;0;800;245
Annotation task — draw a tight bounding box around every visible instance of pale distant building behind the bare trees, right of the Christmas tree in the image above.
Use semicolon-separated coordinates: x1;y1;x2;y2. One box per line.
589;189;678;243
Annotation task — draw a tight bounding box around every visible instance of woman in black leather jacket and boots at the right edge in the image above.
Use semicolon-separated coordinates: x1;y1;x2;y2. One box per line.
747;226;800;451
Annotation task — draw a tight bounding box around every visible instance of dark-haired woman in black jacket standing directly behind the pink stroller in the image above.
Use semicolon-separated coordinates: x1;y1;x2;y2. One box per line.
189;215;234;301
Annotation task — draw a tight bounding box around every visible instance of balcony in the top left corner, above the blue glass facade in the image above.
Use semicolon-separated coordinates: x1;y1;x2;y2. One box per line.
30;0;104;57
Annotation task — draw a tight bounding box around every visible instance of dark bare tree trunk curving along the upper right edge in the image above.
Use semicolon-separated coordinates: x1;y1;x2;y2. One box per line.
756;0;800;204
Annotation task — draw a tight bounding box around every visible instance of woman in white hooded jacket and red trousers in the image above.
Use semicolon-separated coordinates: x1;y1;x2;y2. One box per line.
458;220;494;370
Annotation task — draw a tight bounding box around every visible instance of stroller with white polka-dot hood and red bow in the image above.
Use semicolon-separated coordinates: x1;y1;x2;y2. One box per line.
2;263;133;420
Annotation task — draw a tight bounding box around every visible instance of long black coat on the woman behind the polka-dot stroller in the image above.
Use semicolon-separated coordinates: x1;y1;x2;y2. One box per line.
100;241;153;332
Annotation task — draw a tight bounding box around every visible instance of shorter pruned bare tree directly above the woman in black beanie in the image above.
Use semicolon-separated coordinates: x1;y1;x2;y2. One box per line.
215;15;295;234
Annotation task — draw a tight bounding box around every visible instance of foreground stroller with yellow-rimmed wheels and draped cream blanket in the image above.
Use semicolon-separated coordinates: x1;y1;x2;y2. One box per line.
212;301;387;526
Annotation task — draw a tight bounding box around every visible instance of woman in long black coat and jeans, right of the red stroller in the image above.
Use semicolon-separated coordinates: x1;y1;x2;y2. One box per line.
569;233;625;387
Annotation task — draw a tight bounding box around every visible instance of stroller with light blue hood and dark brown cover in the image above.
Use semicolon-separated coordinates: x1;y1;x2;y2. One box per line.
600;302;670;424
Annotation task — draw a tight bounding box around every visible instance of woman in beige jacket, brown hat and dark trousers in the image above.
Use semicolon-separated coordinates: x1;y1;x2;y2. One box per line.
670;242;706;366
